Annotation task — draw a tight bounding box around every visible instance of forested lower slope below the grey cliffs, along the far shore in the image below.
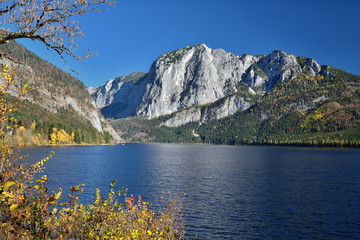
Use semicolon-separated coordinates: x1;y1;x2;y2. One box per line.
112;66;360;147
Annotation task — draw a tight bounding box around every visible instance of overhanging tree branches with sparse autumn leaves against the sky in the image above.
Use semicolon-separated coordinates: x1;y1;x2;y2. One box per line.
0;0;115;63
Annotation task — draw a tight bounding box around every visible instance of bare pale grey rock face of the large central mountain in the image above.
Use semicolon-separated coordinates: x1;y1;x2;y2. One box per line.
88;44;322;126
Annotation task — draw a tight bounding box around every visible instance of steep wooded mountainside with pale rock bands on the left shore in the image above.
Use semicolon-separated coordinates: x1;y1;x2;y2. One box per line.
0;41;118;142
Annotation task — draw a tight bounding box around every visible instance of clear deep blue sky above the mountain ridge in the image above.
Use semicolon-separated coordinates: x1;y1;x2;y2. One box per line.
20;0;360;86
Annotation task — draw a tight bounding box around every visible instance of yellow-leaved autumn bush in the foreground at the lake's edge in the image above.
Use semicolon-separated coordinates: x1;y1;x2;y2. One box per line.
0;66;185;239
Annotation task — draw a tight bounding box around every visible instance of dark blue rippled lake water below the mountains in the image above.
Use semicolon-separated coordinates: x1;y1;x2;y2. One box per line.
22;144;360;239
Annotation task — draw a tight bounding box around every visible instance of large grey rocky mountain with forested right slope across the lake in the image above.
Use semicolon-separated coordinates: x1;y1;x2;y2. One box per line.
90;44;360;146
